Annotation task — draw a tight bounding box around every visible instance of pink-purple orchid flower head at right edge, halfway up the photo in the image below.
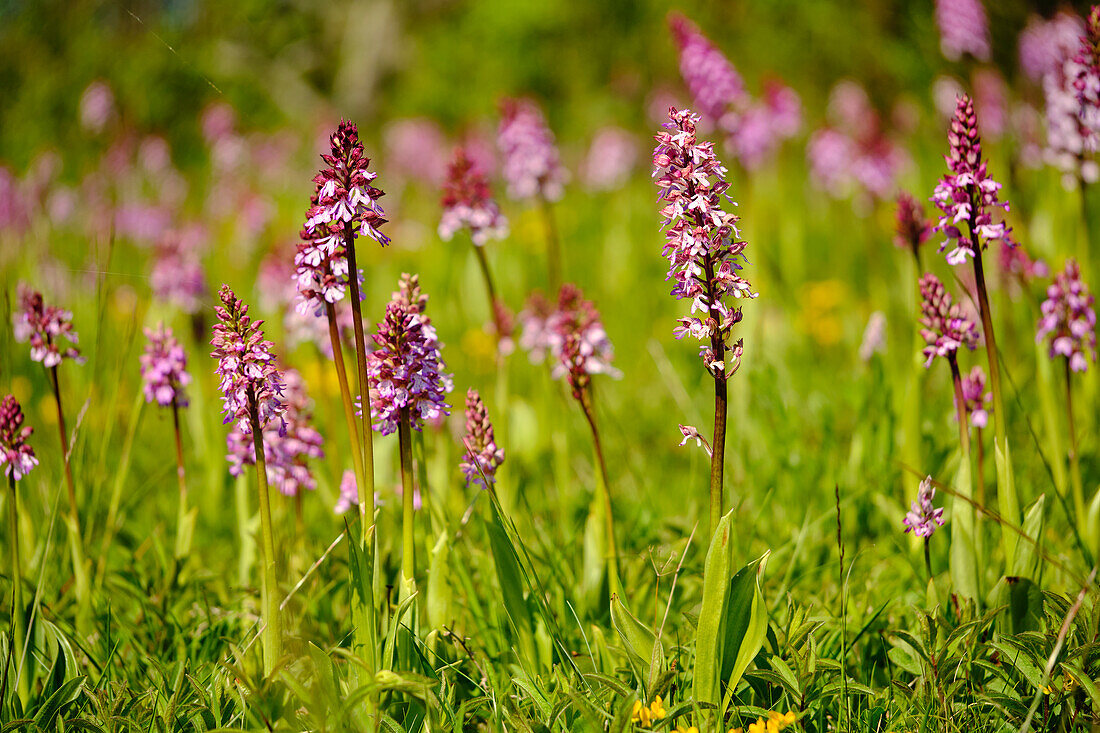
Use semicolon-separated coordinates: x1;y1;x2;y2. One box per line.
1035;260;1097;372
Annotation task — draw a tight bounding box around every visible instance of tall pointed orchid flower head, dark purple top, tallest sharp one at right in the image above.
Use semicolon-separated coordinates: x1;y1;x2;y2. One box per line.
932;95;1012;264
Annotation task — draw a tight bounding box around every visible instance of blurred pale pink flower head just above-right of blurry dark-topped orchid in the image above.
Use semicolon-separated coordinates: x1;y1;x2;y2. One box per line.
496;99;568;201
